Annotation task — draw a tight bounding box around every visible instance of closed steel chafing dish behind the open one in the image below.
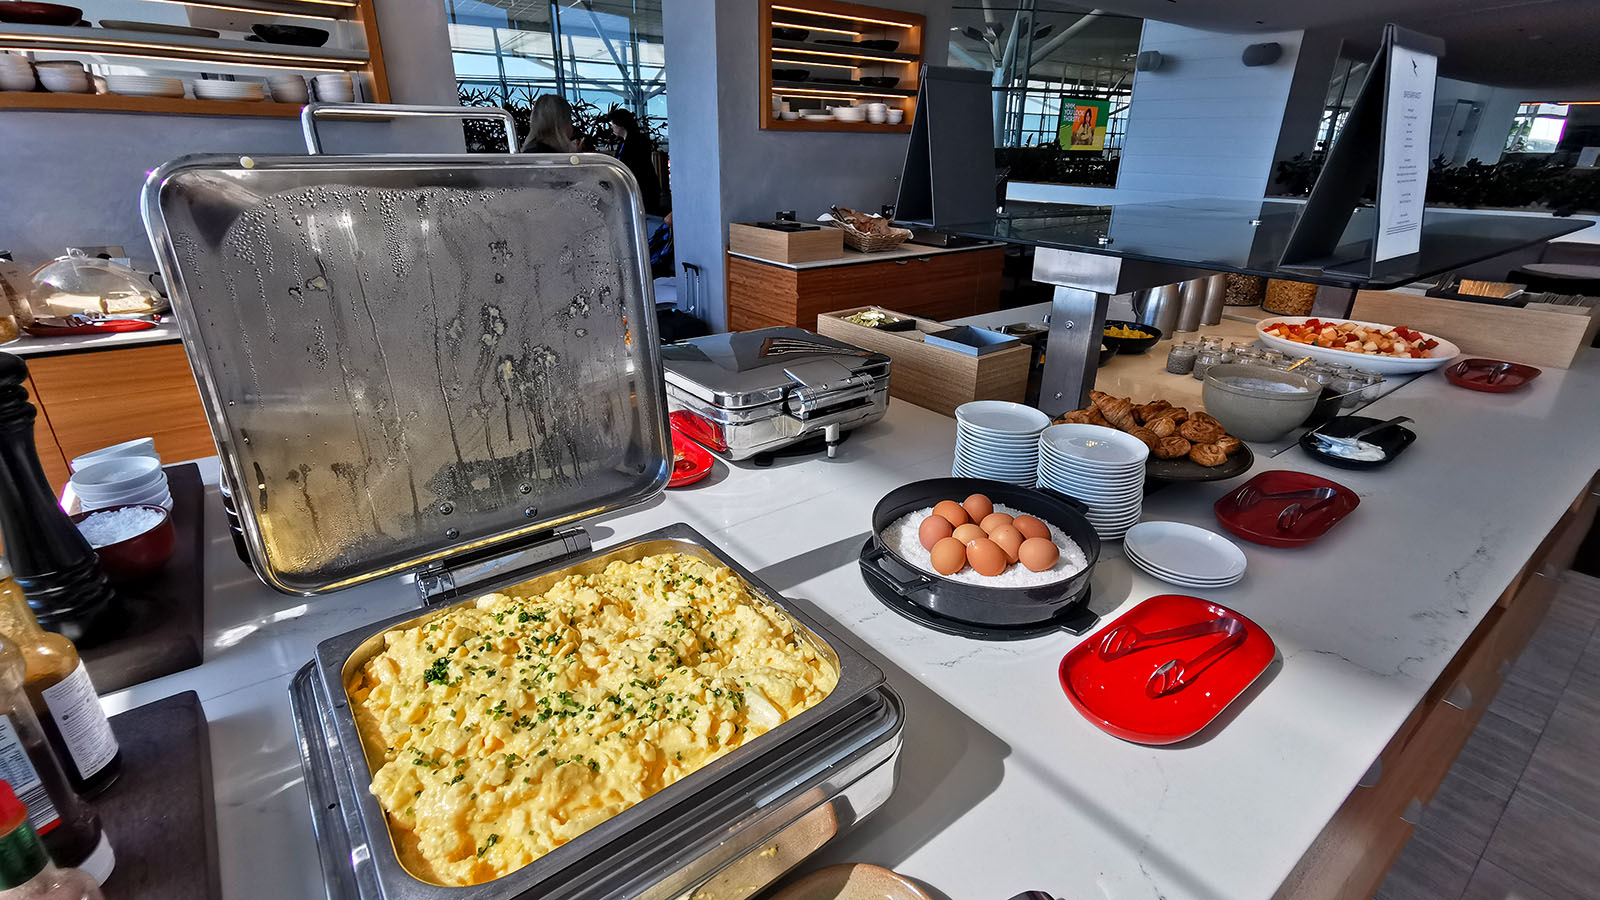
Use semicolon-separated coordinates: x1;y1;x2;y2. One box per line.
661;328;890;460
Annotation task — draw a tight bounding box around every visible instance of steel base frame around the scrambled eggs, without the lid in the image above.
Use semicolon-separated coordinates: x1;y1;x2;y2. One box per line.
291;524;901;900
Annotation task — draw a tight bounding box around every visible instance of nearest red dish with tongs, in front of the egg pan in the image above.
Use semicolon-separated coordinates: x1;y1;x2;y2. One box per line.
1061;594;1278;745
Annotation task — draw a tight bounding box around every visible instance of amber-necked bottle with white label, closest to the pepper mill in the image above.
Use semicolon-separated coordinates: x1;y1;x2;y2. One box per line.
0;560;122;796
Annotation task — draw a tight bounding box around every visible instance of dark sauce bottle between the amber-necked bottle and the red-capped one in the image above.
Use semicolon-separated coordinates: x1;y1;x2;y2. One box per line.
0;637;117;884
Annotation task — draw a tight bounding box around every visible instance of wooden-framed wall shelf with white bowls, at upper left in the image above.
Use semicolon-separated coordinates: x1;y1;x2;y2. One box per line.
0;0;389;119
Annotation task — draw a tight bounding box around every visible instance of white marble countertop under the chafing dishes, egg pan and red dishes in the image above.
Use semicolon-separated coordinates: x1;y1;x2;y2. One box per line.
96;352;1600;900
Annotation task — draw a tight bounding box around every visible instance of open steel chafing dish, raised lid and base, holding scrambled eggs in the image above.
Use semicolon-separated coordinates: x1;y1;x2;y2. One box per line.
144;134;902;900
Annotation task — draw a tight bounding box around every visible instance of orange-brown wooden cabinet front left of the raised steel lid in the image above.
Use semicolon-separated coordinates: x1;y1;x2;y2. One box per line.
29;344;216;488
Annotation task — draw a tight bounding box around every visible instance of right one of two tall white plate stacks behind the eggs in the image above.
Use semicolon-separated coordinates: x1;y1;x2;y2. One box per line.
1038;424;1150;541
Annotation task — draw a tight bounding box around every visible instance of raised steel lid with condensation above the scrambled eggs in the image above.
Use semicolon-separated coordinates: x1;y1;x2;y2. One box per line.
144;154;670;594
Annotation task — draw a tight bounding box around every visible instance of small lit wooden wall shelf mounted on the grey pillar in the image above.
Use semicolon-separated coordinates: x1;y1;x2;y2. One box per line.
757;0;926;135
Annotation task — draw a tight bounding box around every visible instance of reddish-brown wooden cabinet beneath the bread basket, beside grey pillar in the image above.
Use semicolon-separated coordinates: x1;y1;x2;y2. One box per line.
728;245;1005;331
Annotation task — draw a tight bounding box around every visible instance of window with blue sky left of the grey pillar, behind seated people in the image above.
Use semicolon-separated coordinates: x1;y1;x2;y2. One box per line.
445;0;667;149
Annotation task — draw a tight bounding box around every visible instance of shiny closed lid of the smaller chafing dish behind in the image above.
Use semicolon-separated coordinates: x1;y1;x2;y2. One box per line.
661;327;890;408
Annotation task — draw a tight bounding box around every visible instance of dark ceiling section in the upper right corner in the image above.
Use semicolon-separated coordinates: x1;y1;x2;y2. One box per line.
1036;0;1600;101
